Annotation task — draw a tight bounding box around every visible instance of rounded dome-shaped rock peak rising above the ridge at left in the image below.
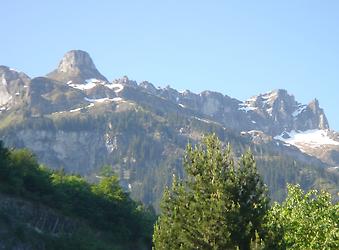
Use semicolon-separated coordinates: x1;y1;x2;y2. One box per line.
47;50;107;84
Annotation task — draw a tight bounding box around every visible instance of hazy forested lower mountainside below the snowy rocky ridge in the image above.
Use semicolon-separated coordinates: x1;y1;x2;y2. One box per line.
0;107;339;211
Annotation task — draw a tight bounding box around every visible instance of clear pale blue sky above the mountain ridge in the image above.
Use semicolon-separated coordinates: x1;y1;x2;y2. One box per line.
0;0;339;131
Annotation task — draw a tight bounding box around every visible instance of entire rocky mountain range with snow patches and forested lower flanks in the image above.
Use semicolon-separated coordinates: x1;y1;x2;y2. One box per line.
0;50;339;209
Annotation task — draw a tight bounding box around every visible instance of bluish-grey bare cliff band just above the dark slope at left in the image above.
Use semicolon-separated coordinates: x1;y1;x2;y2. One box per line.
3;129;107;175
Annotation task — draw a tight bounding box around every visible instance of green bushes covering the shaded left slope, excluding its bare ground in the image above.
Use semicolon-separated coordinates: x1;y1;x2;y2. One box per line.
0;142;155;249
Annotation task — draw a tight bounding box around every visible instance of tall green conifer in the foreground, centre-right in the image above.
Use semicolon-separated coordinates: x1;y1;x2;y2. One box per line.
153;136;268;249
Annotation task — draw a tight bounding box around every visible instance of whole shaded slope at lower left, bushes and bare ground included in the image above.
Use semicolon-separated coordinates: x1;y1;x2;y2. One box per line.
0;143;155;249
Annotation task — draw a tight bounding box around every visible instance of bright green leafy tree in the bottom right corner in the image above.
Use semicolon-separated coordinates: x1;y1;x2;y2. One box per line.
265;185;339;249
